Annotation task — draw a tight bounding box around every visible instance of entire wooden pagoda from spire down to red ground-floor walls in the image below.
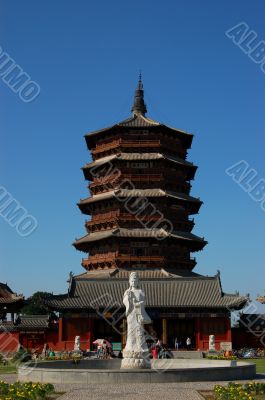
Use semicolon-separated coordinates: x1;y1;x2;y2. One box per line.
48;77;247;350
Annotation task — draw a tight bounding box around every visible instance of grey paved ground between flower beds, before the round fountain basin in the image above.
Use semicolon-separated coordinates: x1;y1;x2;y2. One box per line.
0;374;265;400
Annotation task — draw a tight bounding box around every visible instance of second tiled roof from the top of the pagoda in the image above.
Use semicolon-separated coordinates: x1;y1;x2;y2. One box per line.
83;153;197;169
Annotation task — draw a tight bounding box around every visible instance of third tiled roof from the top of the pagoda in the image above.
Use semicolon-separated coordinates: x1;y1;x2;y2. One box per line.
78;189;202;206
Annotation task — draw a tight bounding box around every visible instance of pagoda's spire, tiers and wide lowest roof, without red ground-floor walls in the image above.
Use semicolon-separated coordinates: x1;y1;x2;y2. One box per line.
46;77;247;310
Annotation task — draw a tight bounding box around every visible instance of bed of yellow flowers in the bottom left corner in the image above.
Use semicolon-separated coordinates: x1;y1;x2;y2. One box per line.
0;381;54;400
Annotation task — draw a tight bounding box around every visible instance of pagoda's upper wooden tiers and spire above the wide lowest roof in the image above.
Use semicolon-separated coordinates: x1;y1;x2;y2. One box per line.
74;79;206;271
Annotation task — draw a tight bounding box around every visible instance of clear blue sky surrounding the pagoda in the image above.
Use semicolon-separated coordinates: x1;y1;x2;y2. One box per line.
0;0;265;306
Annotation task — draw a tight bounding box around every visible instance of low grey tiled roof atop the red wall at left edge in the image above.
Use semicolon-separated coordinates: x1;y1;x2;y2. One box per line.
0;315;49;332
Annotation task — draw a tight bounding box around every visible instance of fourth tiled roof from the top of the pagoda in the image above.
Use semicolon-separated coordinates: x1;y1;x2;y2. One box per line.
74;228;206;250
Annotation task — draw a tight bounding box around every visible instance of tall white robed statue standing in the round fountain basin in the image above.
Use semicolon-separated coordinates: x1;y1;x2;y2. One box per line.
121;272;151;369
